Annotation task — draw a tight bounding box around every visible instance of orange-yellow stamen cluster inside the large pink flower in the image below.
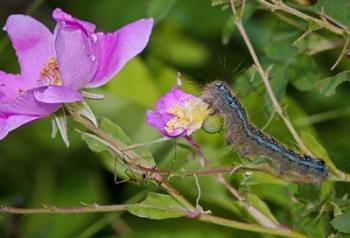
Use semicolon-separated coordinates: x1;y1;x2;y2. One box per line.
39;57;62;86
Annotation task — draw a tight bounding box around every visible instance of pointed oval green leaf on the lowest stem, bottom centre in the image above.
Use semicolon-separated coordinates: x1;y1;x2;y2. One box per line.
128;192;186;220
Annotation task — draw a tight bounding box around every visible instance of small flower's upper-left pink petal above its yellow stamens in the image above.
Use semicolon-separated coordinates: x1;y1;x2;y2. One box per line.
155;86;196;113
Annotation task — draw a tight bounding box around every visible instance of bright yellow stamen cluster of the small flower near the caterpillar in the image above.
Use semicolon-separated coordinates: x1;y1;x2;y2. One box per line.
165;98;210;135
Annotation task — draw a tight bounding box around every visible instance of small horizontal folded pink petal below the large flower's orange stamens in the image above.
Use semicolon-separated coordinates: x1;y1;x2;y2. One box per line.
34;86;84;103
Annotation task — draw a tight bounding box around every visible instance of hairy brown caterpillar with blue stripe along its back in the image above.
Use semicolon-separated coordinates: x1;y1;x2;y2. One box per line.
201;81;328;184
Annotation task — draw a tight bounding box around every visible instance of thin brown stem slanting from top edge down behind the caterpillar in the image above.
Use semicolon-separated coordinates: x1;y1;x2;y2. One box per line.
231;0;311;155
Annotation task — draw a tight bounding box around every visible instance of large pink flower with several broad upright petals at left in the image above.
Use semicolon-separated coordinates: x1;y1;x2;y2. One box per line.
0;9;153;139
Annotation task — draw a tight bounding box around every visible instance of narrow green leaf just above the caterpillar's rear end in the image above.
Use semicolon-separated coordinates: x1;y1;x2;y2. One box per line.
301;132;337;174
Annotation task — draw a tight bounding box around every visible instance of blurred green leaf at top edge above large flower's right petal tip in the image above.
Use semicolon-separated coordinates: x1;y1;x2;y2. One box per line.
147;0;177;23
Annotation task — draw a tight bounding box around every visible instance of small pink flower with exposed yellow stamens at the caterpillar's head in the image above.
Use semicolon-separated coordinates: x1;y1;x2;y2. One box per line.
146;79;210;138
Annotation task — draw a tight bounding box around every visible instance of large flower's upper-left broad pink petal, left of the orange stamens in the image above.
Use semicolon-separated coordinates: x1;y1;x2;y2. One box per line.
4;15;55;89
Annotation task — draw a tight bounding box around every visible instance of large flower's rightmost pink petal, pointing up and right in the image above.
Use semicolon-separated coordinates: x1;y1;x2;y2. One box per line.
88;18;153;87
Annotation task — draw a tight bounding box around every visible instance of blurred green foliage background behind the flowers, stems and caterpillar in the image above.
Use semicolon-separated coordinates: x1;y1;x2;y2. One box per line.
0;0;350;238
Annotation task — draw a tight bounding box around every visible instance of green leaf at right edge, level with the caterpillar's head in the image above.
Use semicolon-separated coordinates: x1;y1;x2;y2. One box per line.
317;71;350;97
